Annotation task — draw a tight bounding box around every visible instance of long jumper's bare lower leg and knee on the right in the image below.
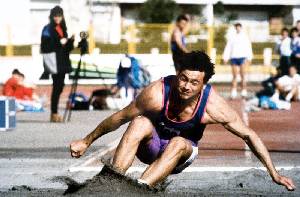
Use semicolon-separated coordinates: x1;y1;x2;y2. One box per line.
141;137;193;186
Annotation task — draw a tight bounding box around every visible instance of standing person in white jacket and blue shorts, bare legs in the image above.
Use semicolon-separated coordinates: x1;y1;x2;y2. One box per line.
223;23;253;99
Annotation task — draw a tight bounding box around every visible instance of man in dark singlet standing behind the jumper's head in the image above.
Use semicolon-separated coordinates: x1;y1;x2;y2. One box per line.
171;15;189;72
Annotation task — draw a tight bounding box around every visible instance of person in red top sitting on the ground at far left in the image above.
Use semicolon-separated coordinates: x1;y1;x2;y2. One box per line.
3;69;43;111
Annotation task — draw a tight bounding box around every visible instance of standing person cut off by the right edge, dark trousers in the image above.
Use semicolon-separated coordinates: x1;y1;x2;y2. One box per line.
290;27;300;73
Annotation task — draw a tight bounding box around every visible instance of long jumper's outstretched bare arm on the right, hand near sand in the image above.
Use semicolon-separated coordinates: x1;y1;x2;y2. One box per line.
203;90;295;190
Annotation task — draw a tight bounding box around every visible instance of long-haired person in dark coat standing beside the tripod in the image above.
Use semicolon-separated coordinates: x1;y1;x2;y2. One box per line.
41;6;74;122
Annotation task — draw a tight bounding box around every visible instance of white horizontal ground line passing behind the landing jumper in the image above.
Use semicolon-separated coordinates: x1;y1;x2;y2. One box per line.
72;165;300;174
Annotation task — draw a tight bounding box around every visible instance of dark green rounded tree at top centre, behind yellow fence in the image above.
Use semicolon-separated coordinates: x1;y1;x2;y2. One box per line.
139;0;179;23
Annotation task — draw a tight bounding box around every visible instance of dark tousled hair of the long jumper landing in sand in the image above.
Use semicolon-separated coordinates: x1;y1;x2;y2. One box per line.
178;51;215;83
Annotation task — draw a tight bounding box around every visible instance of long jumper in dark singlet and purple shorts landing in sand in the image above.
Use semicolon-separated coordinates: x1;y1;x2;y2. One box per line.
70;51;295;190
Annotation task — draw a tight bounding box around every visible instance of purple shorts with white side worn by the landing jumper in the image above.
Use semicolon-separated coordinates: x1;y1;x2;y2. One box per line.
136;129;198;174
